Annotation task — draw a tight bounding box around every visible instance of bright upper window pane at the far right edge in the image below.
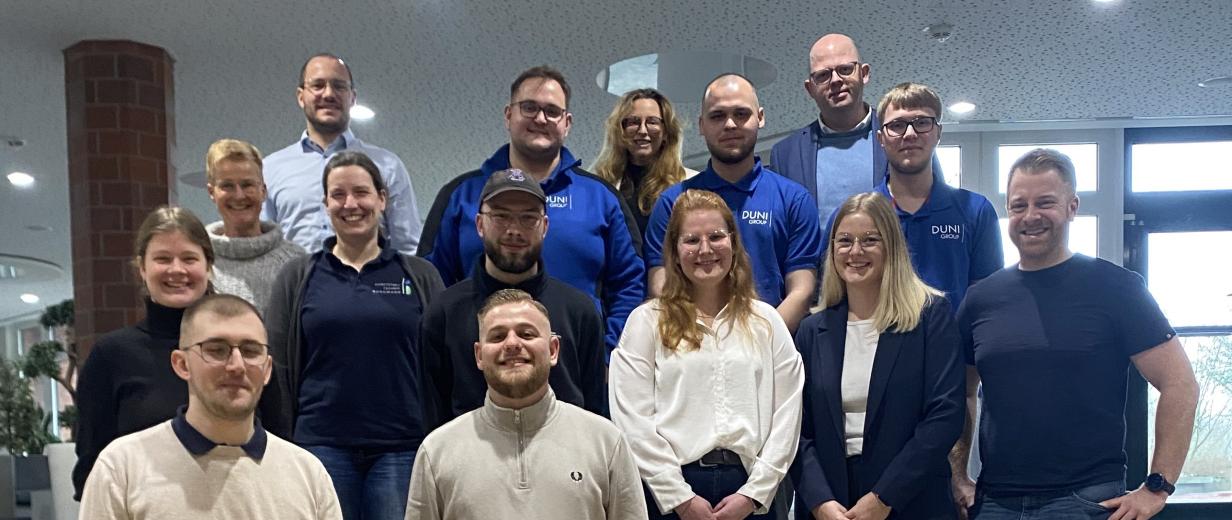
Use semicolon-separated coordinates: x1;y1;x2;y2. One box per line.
1130;140;1232;192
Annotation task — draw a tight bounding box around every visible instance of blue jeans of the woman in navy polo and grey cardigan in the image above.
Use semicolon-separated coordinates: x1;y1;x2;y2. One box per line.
304;446;415;520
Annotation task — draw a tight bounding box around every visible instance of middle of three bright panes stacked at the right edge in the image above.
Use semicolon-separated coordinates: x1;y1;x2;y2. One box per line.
1147;232;1232;327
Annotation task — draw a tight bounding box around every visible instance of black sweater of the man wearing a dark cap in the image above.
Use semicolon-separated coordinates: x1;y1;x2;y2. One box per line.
419;256;607;431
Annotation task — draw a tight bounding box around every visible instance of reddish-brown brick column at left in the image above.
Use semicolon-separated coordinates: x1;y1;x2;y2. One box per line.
64;41;175;360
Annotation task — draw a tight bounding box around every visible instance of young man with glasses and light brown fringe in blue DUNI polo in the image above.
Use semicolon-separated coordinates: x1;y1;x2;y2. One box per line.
877;83;1004;309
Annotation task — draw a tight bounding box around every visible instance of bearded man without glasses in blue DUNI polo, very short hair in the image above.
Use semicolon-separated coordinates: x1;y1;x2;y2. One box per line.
646;74;818;331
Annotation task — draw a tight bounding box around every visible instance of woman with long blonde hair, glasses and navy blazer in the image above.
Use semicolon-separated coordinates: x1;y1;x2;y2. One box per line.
791;193;966;520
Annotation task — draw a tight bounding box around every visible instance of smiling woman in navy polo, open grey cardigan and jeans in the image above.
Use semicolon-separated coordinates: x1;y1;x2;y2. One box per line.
261;152;444;519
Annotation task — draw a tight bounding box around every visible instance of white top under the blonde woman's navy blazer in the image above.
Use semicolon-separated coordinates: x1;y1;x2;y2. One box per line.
840;319;881;457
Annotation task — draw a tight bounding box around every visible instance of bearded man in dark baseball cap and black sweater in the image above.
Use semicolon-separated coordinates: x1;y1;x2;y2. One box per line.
419;169;607;430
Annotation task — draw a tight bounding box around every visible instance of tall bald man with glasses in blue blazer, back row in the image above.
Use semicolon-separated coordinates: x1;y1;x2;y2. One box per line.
770;33;940;218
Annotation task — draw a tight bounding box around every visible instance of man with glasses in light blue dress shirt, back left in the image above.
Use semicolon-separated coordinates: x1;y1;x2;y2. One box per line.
261;54;423;255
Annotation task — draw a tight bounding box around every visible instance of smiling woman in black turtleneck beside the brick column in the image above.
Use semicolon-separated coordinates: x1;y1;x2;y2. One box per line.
73;207;214;499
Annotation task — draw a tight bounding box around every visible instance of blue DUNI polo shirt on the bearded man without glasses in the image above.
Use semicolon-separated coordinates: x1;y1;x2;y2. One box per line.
644;159;822;307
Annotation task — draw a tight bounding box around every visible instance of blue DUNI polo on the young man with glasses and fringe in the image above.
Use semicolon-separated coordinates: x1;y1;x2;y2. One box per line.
872;170;1005;309
